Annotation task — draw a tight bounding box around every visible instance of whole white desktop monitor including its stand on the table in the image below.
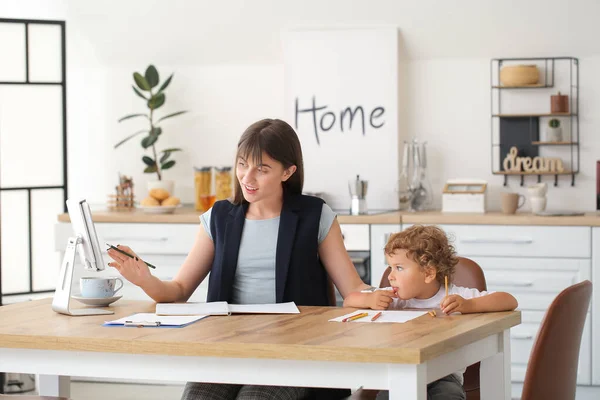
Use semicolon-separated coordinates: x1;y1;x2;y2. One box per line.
52;199;114;315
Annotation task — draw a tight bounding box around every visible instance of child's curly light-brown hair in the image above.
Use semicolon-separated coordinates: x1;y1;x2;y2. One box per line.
384;225;458;284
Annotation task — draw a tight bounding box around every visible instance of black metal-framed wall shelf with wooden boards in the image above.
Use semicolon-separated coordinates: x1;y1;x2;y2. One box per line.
490;57;580;186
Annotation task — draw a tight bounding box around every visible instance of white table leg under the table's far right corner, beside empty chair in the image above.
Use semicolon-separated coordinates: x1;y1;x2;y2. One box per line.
479;329;511;400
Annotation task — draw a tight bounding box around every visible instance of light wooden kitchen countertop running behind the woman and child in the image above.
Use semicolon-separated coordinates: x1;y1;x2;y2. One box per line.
58;207;600;226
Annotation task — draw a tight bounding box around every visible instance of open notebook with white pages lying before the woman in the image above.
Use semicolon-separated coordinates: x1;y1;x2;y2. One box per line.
156;301;300;315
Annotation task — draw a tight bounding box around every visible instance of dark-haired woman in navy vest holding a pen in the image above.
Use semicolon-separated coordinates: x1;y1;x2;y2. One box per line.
108;119;369;400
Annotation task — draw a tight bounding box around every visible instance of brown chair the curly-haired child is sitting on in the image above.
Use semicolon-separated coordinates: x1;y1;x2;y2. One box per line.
350;257;487;400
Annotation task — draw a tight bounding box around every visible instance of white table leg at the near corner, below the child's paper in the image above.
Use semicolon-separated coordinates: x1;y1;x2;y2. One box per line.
388;364;427;400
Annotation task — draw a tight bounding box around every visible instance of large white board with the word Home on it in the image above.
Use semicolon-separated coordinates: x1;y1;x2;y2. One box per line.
283;28;398;209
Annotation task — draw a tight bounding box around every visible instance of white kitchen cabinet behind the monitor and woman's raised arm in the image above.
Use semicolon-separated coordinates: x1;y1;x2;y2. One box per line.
55;223;208;301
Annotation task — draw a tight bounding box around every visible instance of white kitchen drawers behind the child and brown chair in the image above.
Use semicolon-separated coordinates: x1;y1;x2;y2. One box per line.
402;225;600;385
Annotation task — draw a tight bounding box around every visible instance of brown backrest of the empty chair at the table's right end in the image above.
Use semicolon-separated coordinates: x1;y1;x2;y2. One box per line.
521;281;592;400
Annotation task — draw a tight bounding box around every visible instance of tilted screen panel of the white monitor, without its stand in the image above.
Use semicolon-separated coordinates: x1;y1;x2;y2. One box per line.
67;199;105;271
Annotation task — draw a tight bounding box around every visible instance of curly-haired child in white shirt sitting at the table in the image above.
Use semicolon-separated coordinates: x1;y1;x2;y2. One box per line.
344;225;517;400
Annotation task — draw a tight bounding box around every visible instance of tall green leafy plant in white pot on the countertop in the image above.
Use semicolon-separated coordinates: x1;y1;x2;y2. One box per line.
115;65;187;194
